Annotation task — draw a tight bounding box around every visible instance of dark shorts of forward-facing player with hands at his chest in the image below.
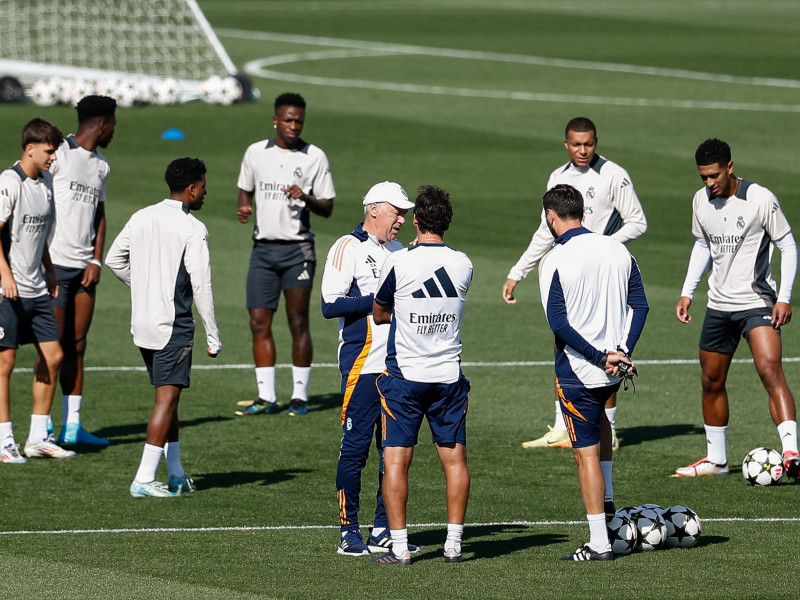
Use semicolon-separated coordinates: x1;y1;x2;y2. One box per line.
247;240;316;310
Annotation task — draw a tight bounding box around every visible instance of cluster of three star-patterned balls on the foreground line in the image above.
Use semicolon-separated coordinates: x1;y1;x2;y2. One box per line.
607;504;702;556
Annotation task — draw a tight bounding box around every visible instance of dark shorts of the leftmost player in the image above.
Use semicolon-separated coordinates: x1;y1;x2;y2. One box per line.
0;295;58;348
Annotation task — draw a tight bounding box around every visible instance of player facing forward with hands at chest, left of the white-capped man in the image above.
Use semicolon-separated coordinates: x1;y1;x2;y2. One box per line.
236;94;336;416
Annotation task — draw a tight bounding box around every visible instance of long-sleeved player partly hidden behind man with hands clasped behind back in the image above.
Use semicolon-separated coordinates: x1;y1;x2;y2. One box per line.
502;117;647;450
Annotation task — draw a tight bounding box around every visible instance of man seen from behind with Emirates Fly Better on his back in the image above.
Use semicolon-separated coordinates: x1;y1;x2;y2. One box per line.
372;186;472;565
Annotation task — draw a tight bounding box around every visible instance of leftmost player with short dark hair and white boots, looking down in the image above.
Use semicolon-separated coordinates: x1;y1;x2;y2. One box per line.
0;119;75;464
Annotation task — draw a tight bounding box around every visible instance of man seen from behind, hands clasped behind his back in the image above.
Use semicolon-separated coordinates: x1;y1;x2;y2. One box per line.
539;184;649;561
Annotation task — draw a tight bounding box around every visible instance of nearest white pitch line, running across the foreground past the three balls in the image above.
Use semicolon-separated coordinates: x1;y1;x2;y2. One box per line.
0;517;800;536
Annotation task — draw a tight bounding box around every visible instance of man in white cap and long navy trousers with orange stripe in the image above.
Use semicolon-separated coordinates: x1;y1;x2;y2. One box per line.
321;181;414;556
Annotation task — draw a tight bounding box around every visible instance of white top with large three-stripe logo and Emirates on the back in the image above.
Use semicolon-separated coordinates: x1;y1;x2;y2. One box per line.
375;244;472;383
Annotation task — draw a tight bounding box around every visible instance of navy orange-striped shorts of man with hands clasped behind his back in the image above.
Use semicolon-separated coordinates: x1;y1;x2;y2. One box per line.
558;383;619;448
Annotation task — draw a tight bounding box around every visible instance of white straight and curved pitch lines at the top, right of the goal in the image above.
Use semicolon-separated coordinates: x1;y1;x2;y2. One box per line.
217;29;800;113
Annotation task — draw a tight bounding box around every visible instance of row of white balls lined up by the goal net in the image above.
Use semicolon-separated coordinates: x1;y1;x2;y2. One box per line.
28;75;242;107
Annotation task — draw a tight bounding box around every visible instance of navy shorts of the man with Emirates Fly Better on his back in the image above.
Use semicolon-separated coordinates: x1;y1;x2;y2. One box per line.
376;373;470;447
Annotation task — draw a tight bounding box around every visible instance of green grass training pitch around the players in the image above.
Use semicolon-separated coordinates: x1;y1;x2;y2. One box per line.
0;0;800;599
